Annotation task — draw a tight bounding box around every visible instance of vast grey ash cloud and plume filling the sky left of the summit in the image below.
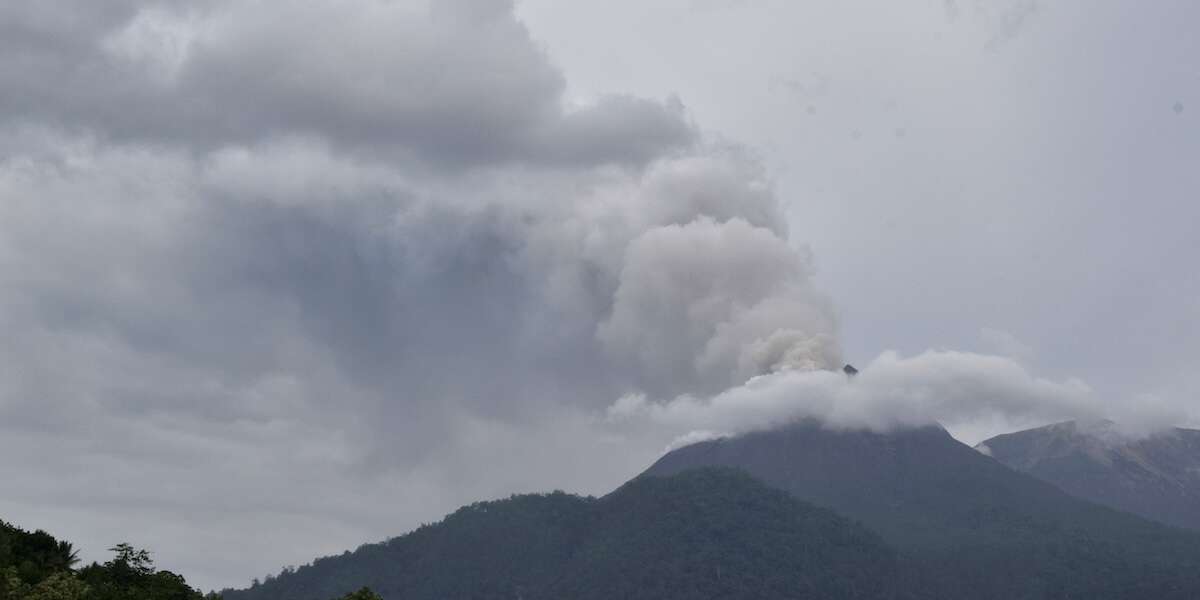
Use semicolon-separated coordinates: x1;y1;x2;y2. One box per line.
0;0;838;587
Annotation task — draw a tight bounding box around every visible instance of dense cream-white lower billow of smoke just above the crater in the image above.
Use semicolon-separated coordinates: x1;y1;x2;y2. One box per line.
598;217;840;392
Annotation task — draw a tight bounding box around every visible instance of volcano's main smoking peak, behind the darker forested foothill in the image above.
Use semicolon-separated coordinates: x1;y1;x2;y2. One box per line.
642;422;1200;599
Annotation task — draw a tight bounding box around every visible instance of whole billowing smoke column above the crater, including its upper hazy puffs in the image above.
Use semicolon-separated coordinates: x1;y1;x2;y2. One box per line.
508;150;841;397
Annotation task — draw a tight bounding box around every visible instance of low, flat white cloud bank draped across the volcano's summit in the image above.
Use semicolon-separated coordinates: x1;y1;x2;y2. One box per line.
607;350;1104;440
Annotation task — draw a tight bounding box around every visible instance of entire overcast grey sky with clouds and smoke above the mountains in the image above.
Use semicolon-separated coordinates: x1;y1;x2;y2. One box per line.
0;0;1200;588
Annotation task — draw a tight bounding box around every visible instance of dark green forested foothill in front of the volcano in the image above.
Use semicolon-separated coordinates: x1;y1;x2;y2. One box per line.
223;469;928;600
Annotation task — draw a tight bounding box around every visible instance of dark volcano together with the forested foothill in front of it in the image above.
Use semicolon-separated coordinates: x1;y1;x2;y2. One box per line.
224;422;1200;600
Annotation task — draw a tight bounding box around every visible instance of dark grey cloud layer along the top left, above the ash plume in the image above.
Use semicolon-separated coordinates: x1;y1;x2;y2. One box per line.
0;0;694;166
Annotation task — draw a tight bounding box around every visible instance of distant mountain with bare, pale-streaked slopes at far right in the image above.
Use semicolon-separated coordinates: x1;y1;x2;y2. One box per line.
976;421;1200;530
